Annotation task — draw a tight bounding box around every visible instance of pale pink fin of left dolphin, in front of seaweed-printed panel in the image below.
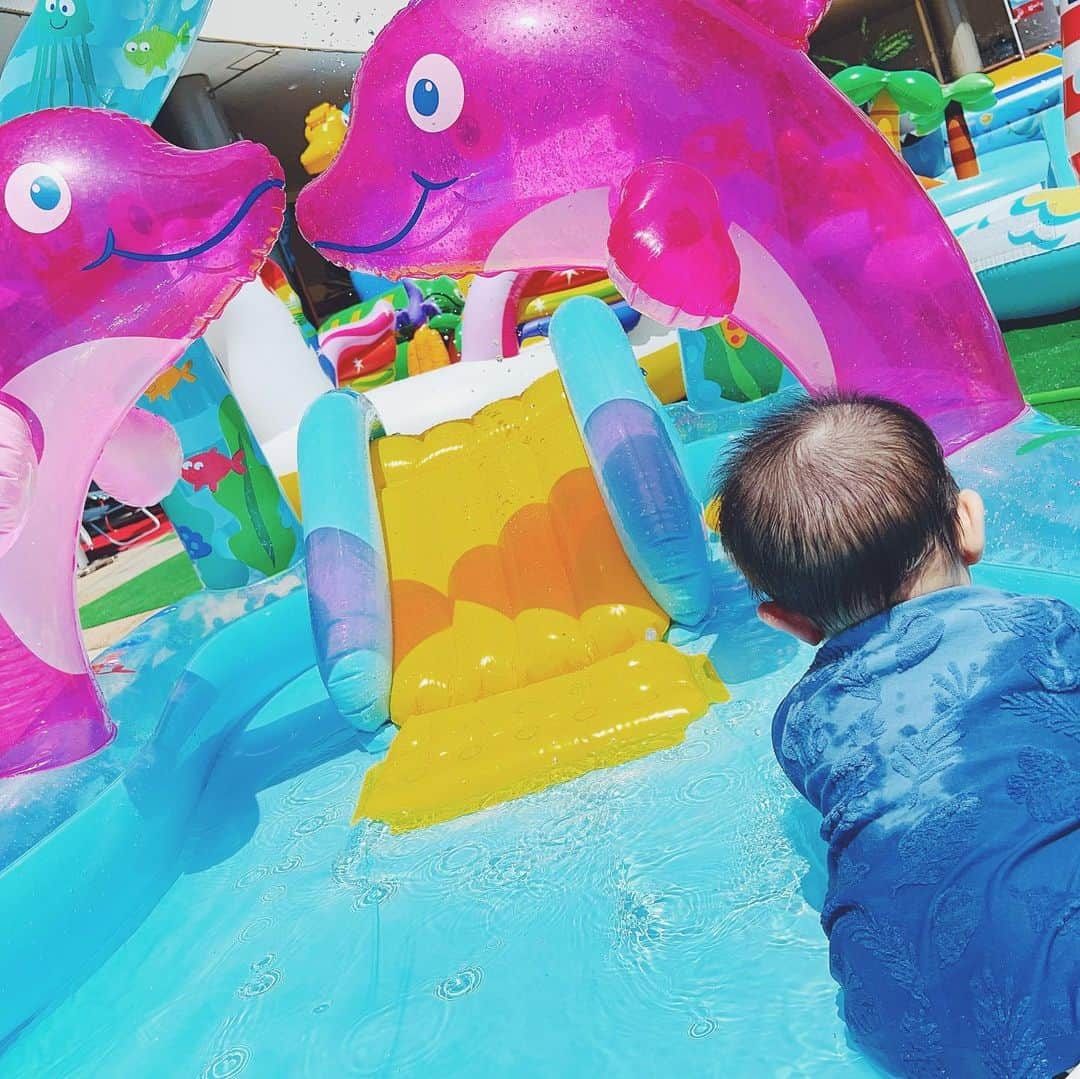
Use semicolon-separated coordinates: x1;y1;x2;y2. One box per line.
94;408;184;505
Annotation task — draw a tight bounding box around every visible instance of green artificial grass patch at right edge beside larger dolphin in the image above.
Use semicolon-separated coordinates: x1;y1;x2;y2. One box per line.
1005;311;1080;427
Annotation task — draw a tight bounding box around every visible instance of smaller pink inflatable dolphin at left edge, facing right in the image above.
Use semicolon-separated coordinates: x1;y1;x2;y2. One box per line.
0;109;285;775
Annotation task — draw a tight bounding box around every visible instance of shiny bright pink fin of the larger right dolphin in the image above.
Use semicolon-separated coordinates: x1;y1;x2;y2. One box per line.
607;161;740;329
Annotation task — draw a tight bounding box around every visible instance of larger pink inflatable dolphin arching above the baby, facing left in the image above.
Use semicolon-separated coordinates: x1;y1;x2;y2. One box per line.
298;0;1023;449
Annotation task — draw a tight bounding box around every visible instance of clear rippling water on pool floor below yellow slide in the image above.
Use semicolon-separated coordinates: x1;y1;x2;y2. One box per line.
2;656;877;1079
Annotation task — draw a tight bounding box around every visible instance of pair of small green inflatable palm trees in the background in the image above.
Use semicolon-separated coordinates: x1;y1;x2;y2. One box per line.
833;65;997;179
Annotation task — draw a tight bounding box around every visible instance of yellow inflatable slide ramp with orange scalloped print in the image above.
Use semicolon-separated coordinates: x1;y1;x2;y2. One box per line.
356;374;727;832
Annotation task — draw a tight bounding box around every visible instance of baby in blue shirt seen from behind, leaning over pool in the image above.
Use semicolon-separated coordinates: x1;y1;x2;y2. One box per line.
719;396;1080;1079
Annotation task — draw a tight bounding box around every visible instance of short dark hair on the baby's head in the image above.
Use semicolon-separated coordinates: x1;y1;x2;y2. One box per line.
717;393;962;636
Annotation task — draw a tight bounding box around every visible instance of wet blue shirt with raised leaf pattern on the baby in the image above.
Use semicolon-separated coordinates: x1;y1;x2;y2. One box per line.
772;588;1080;1079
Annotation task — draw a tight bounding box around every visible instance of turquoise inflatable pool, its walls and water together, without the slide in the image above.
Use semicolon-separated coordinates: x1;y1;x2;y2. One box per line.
6;406;1080;1079
